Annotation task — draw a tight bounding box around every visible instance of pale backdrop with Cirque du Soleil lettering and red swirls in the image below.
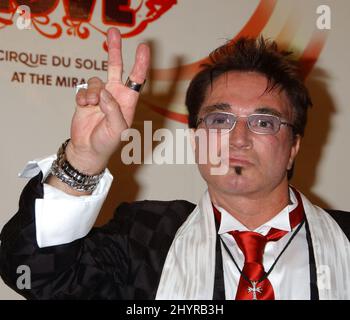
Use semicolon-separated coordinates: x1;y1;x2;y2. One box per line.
0;0;350;299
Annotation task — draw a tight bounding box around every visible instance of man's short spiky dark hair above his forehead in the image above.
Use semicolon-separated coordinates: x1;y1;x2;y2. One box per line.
186;37;312;136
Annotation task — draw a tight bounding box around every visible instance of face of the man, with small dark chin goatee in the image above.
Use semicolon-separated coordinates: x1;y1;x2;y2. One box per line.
197;72;300;197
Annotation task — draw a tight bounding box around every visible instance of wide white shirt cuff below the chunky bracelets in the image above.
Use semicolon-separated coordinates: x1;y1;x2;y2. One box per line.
19;155;113;248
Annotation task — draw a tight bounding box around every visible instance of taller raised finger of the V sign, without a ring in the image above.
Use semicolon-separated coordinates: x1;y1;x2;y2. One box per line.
107;28;123;82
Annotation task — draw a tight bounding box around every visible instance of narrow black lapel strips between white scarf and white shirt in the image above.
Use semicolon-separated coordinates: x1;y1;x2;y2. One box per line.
213;218;319;300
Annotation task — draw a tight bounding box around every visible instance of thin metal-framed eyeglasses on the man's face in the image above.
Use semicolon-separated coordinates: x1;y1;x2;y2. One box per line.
197;112;294;134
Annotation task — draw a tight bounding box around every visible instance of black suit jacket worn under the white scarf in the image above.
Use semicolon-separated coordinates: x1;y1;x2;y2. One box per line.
0;174;350;299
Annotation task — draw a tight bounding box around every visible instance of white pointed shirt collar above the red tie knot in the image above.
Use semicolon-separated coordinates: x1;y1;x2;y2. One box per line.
216;188;298;235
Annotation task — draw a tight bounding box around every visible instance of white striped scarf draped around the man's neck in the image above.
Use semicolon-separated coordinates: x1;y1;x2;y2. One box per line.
156;191;350;300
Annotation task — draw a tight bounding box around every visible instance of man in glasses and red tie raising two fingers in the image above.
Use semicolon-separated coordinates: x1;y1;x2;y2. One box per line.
1;29;350;300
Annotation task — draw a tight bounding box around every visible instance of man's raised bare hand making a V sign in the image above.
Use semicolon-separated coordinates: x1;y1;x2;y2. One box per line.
66;28;150;174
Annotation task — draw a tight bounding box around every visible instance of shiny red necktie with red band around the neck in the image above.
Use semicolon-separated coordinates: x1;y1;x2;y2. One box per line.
213;188;304;300
